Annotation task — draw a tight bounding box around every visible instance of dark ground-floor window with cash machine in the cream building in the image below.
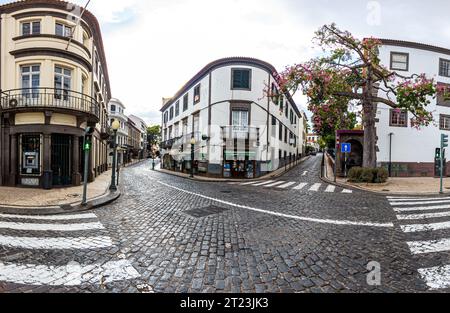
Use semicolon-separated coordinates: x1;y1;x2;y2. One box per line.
20;135;41;175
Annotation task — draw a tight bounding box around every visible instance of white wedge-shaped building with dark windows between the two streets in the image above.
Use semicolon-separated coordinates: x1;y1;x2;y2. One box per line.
161;57;304;179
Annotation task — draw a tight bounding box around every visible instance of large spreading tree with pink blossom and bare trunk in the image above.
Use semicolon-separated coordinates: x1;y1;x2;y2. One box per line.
277;24;449;167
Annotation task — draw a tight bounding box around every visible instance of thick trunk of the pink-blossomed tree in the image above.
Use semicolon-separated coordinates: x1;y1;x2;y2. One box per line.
363;100;377;168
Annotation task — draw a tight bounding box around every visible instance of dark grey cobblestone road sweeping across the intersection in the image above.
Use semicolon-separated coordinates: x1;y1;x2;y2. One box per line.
0;156;448;293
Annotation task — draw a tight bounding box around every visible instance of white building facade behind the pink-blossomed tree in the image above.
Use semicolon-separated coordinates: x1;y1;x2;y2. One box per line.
377;39;450;177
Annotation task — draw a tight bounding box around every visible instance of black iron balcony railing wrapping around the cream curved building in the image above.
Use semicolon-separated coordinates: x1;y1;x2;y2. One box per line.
0;88;100;119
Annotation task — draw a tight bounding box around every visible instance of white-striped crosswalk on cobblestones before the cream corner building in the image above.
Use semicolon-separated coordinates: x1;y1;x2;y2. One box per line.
0;213;140;286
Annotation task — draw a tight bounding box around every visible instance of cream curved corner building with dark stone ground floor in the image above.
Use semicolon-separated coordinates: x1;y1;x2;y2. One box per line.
0;0;111;189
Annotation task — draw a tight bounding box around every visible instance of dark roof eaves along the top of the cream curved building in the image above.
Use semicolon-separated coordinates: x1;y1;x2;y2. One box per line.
0;0;112;97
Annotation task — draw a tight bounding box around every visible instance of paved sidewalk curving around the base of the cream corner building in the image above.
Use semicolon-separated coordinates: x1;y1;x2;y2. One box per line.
0;171;111;208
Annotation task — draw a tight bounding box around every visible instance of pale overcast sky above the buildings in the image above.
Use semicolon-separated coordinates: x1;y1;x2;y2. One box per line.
0;0;450;124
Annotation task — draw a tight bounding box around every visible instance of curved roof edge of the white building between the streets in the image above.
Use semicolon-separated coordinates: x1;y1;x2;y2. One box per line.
161;57;302;116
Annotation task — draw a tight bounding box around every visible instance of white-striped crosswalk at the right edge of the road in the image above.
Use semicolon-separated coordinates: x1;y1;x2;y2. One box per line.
388;197;450;290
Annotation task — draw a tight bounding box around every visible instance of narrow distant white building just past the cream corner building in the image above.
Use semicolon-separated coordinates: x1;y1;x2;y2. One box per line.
108;98;128;166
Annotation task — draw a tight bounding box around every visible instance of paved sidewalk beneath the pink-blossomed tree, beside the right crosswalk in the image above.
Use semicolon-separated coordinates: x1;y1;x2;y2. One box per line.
324;152;450;195
